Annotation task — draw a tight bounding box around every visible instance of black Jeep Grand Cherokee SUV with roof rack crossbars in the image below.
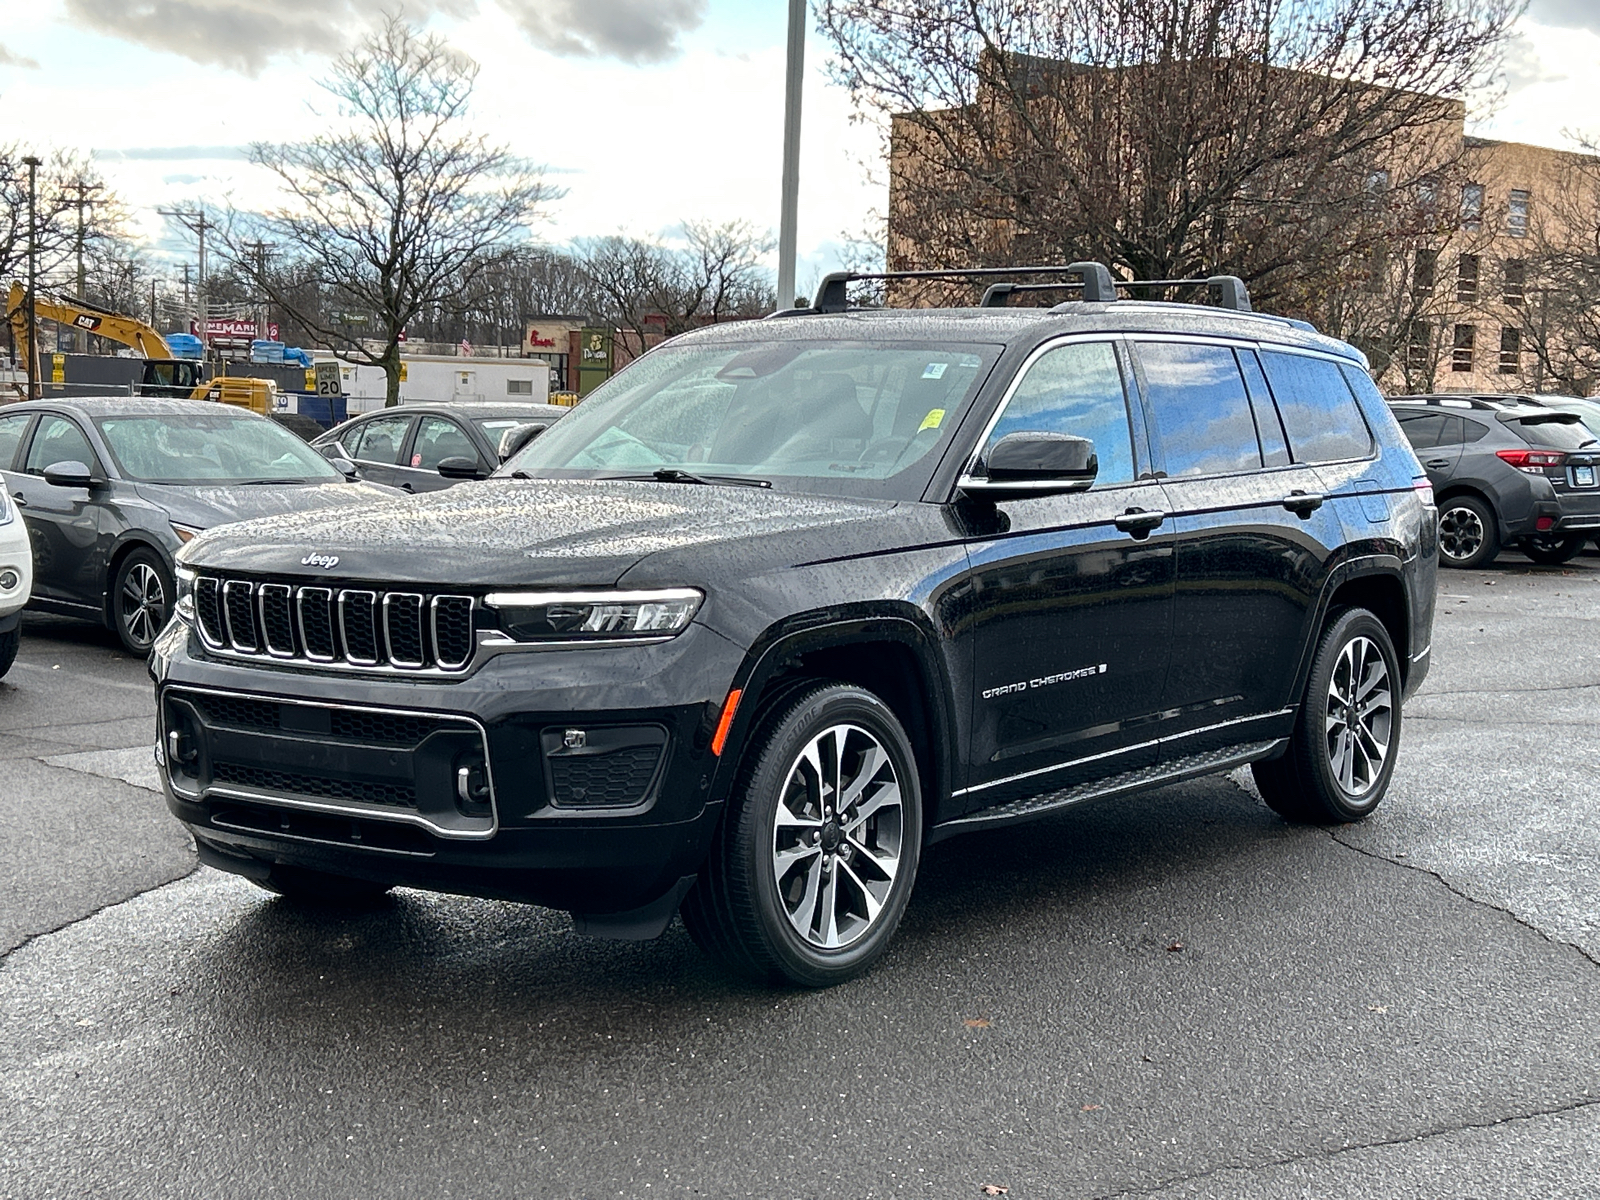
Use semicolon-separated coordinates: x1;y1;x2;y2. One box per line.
150;264;1437;986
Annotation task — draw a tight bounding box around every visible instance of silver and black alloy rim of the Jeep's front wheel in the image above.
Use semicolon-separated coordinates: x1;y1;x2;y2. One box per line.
771;725;906;950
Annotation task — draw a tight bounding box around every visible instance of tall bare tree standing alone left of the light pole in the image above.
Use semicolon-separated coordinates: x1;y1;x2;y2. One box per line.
222;16;557;405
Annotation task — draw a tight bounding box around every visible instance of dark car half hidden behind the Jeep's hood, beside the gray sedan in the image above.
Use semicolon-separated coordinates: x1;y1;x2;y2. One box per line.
312;405;571;491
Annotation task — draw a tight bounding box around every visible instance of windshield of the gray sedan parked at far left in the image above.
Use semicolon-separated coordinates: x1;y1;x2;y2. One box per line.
94;411;344;483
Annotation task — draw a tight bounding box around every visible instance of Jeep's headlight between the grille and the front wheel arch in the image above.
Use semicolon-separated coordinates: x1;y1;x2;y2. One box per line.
483;587;706;642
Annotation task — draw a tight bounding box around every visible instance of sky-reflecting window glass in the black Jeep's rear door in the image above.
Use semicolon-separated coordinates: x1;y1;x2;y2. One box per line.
1139;342;1261;478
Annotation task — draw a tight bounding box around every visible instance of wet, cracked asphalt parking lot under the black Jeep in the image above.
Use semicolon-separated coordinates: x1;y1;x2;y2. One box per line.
0;554;1600;1200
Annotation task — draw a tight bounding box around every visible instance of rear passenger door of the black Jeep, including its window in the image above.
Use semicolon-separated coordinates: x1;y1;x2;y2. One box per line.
1136;338;1365;758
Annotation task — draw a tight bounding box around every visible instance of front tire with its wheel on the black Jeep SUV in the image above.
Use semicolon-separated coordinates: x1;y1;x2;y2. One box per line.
682;683;922;987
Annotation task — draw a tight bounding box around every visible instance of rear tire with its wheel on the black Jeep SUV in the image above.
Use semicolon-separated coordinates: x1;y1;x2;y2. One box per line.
1251;608;1400;824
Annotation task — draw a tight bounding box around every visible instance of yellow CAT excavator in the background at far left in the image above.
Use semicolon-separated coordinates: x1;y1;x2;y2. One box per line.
5;283;277;416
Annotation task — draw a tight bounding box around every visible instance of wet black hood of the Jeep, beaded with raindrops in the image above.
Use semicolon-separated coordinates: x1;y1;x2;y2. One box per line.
181;480;894;587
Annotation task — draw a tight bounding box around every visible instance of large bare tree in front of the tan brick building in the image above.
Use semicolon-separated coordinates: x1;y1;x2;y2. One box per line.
819;0;1522;309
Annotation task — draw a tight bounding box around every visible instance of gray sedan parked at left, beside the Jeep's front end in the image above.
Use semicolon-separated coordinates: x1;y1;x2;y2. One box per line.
0;397;397;656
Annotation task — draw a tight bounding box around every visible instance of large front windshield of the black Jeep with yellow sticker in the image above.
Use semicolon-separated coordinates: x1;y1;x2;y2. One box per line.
496;341;1000;499
